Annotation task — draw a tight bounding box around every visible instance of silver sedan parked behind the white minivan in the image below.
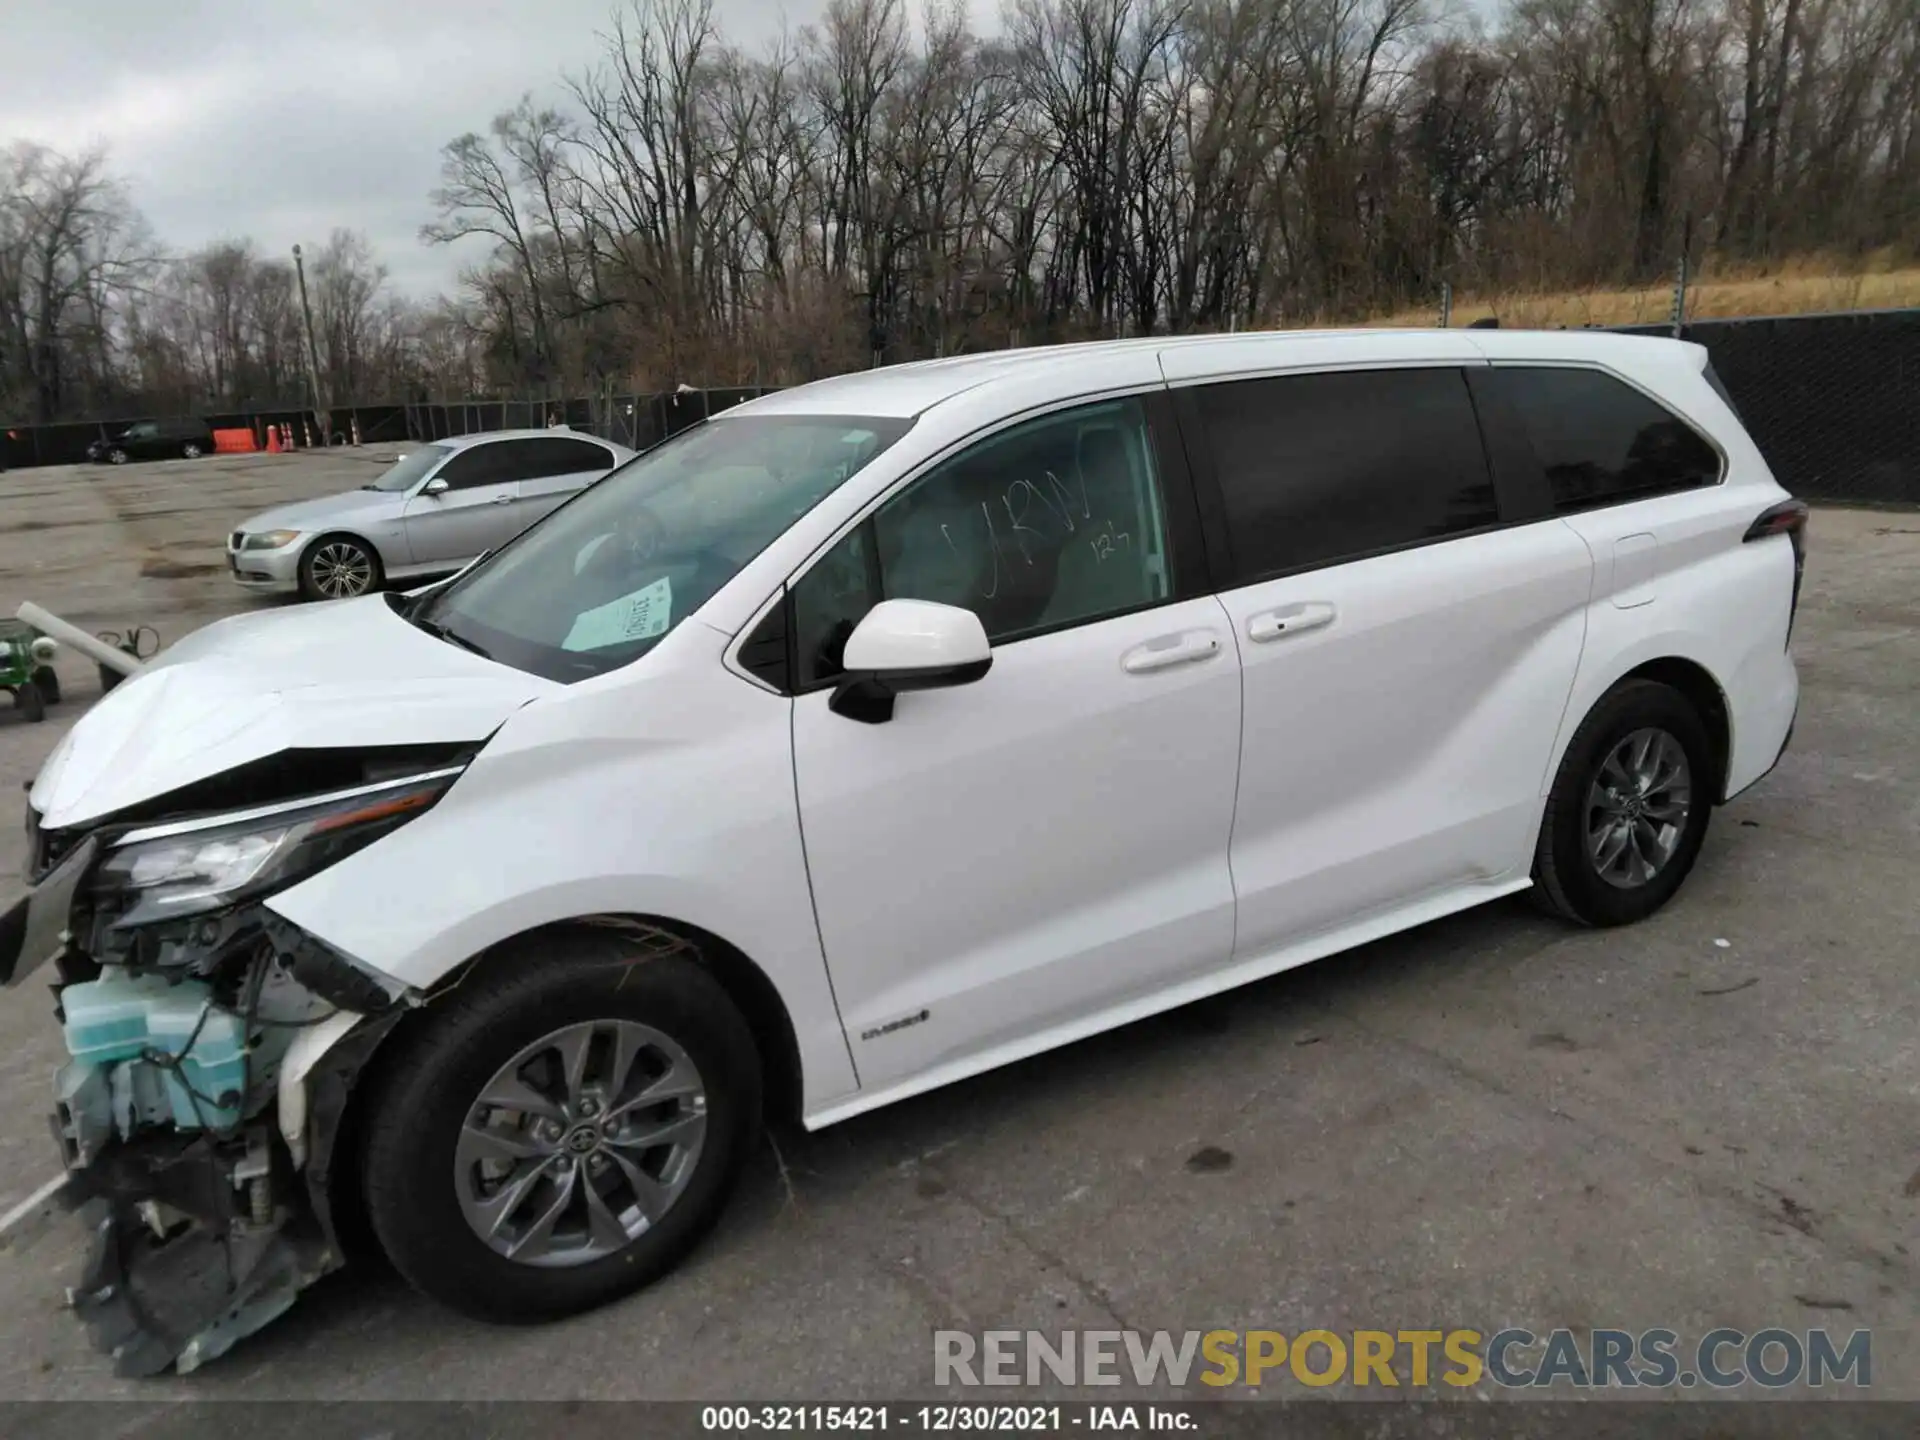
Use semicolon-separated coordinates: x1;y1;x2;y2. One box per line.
227;430;634;599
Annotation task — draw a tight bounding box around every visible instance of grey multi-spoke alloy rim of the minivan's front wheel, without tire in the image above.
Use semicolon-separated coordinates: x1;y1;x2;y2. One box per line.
453;1020;707;1265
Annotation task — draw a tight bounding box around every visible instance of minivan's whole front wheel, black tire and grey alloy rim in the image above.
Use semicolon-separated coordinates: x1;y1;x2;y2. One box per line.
361;931;760;1325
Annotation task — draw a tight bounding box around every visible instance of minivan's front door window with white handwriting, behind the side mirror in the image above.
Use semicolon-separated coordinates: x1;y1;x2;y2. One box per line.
793;399;1173;689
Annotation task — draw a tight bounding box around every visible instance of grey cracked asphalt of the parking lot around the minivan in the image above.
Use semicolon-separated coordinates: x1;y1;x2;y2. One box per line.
0;449;1920;1400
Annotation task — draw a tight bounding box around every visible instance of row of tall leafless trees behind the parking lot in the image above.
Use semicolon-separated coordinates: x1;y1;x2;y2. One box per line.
11;0;1920;426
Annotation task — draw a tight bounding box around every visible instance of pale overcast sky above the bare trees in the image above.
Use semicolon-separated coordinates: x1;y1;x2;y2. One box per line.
0;0;820;296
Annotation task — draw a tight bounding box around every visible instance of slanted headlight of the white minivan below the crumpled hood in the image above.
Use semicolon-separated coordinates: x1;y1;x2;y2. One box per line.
94;770;459;925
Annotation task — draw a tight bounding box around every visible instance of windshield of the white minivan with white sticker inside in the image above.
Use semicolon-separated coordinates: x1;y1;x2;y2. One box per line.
411;415;912;682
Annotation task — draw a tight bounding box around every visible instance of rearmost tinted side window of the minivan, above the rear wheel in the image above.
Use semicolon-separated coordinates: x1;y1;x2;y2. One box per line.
1492;365;1720;515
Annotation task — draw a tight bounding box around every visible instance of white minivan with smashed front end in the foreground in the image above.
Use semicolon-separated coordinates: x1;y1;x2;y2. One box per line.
0;330;1807;1373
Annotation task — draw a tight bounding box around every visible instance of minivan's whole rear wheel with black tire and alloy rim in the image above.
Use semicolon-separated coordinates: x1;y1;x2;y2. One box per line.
1534;680;1718;925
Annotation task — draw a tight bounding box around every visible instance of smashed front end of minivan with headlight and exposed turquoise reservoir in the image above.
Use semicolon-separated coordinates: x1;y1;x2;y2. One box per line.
0;747;472;1377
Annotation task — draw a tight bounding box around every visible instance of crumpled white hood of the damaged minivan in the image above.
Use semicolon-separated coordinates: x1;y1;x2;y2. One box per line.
31;595;564;829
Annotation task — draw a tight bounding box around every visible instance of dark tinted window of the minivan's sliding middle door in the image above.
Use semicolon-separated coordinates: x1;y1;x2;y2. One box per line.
1198;369;1500;584
